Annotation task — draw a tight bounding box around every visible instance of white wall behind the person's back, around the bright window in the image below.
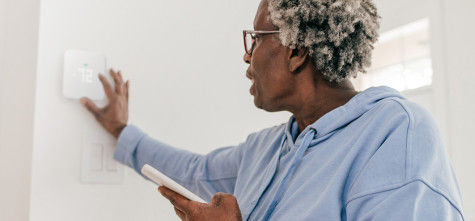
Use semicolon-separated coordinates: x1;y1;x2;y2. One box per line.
376;0;475;220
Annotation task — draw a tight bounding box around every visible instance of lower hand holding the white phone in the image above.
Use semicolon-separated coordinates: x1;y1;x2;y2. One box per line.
158;186;242;221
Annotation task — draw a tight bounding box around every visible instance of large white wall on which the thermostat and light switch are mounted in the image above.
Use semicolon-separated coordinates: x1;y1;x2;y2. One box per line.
30;0;289;221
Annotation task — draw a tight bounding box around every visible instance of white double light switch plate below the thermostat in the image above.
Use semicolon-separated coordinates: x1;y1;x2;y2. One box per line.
80;129;124;184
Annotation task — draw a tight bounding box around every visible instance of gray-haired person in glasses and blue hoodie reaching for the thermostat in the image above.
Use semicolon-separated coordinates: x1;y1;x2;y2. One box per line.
82;0;463;220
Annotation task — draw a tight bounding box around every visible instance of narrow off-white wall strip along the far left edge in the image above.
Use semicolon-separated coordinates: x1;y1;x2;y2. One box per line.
0;0;39;221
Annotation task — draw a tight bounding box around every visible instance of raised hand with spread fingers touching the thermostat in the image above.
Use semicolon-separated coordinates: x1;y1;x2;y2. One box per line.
81;69;129;138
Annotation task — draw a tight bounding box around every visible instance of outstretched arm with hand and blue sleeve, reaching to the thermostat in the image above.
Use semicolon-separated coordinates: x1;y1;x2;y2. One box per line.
81;69;244;201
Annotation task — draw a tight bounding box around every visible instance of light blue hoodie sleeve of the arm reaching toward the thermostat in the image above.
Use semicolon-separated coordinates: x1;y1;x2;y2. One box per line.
114;125;245;201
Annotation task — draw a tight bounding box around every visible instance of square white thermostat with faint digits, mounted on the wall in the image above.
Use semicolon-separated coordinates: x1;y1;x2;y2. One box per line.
63;50;111;100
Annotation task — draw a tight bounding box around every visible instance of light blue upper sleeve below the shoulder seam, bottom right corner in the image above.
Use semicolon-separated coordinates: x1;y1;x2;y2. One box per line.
344;180;463;221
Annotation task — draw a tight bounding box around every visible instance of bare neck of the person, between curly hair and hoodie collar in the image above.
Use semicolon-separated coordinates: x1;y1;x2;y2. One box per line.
290;76;358;134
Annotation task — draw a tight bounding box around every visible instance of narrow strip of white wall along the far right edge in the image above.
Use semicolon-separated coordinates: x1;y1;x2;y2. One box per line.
442;0;475;220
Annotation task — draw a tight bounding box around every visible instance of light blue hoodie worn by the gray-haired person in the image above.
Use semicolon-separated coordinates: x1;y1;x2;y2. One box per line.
114;87;463;220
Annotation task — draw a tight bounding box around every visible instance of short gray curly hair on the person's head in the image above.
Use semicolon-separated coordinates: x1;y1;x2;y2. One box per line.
268;0;380;82
